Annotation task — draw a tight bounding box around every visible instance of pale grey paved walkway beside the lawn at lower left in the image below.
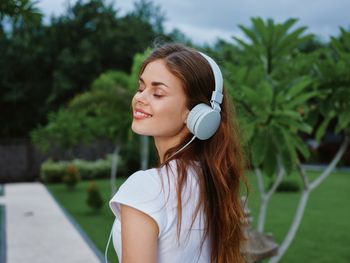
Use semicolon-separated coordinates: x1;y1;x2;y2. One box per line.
0;183;101;263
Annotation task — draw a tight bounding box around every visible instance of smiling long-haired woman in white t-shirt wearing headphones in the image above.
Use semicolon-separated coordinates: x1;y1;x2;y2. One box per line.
110;44;244;263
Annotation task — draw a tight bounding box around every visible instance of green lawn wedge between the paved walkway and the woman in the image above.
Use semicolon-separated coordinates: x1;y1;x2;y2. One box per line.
47;179;124;262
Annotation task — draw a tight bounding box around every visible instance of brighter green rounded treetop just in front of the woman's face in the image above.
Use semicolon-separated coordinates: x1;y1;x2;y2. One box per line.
68;71;131;141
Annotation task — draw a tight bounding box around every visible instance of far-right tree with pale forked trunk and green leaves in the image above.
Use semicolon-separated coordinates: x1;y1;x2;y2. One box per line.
271;28;350;262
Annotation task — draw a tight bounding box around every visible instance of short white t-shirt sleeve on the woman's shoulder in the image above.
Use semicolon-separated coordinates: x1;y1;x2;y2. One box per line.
109;170;167;235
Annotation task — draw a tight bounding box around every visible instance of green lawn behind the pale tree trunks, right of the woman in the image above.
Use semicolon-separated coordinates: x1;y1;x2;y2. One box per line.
249;173;350;263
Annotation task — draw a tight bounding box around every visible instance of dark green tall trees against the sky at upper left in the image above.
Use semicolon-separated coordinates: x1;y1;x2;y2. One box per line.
0;0;167;137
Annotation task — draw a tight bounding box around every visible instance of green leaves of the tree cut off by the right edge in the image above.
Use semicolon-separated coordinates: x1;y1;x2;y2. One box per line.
316;28;350;140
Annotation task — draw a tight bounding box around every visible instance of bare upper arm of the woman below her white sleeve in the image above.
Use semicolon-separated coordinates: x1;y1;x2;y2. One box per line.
121;205;159;263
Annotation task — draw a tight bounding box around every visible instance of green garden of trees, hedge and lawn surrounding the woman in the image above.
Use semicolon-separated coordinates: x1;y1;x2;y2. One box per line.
0;0;350;263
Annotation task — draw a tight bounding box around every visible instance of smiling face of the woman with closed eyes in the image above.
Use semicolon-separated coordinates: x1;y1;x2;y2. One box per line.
132;59;189;139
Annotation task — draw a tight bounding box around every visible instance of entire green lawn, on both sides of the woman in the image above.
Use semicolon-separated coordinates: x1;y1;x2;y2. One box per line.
48;170;350;263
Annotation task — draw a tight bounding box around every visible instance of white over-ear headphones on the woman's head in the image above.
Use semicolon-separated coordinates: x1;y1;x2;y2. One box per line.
187;52;223;140
